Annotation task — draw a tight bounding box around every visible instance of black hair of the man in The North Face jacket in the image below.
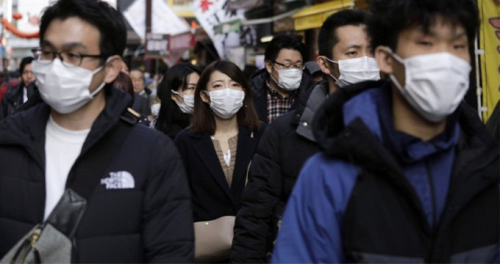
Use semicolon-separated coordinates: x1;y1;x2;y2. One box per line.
40;0;127;57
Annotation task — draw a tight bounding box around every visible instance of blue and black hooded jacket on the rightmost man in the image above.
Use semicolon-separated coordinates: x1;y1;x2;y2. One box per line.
273;81;500;263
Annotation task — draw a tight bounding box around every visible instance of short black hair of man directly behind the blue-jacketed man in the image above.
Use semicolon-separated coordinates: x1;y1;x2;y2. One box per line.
318;9;369;59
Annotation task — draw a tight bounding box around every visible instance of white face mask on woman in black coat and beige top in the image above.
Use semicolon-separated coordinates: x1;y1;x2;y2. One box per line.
204;88;245;119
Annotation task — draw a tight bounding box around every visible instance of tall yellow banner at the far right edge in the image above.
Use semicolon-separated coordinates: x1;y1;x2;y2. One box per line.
478;0;500;122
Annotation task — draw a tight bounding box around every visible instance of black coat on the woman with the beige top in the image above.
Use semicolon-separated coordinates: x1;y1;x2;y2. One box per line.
175;126;260;222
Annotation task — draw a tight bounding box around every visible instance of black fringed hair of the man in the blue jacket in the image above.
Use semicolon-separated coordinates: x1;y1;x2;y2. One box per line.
368;0;479;52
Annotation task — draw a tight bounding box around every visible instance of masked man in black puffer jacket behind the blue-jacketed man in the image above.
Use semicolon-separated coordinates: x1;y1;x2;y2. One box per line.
232;10;379;262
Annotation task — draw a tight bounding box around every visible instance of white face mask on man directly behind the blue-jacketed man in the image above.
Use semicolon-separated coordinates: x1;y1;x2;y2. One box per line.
323;56;380;88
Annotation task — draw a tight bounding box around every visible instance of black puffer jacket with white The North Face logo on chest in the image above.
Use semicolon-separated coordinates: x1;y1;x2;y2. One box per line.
0;88;193;263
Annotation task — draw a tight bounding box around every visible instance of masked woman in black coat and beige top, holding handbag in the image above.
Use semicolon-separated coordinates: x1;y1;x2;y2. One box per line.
175;61;260;262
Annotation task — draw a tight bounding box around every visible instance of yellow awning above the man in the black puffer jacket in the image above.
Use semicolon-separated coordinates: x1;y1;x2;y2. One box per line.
293;0;355;30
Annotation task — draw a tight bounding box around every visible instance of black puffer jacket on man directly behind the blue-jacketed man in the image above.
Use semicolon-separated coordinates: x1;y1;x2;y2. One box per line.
232;81;328;263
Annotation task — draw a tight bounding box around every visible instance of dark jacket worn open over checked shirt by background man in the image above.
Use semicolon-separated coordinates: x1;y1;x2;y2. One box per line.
251;68;312;124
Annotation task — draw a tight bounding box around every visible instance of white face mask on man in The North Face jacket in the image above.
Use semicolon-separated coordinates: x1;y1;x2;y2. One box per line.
33;58;105;114
